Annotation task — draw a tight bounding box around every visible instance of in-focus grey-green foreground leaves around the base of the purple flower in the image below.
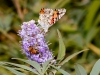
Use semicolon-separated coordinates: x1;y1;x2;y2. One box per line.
0;30;100;75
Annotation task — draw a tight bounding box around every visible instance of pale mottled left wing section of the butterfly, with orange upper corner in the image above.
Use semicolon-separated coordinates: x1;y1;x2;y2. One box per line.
38;8;53;32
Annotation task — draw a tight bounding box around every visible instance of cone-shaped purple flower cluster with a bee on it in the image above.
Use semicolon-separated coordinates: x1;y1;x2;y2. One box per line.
19;20;53;64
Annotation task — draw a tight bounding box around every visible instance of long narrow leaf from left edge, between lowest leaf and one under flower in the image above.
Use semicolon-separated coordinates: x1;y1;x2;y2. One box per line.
0;62;39;74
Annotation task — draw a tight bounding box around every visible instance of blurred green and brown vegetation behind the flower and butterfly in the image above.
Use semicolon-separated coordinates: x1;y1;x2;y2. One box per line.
0;0;100;75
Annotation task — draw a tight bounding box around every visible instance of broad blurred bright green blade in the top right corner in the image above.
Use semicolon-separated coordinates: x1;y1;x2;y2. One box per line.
84;0;100;31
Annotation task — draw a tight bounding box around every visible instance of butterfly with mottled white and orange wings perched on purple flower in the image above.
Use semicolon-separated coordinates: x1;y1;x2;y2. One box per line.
38;8;66;32
